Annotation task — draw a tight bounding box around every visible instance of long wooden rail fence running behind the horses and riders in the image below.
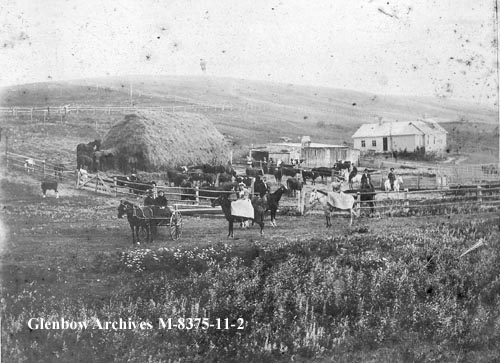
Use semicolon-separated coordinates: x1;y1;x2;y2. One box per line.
5;152;500;219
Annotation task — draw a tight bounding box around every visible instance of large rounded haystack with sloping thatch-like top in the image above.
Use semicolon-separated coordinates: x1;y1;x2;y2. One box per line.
101;112;229;171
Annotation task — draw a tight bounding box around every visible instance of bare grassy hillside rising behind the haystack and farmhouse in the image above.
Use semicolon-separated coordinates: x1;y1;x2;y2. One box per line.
0;76;498;161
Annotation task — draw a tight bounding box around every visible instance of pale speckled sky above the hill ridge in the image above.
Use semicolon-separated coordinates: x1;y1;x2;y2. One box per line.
0;0;498;106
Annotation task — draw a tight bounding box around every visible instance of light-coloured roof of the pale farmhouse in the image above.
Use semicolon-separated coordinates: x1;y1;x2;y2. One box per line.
352;120;447;139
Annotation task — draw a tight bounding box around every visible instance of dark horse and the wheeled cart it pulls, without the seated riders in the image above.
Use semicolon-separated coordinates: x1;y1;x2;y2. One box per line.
118;200;182;244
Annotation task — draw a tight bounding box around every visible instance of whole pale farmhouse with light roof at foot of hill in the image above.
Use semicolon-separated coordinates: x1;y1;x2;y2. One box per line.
352;119;448;154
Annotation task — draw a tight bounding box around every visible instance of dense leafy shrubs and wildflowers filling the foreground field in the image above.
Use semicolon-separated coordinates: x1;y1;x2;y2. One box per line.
2;220;500;362
